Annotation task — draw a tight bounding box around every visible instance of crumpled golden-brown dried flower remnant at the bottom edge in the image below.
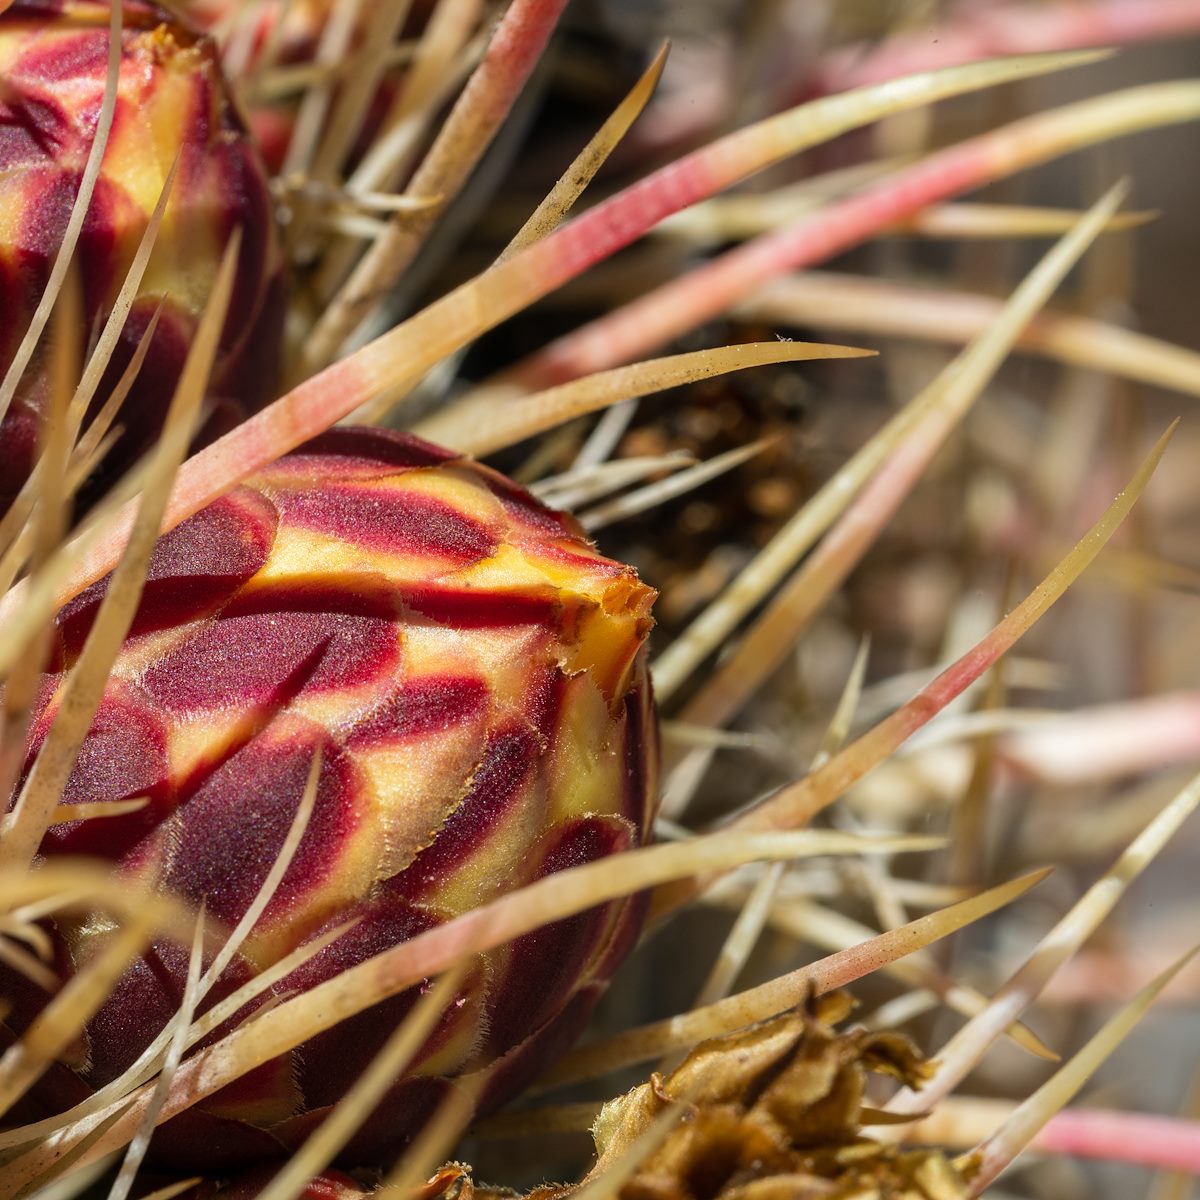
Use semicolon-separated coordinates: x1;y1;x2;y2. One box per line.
474;992;970;1200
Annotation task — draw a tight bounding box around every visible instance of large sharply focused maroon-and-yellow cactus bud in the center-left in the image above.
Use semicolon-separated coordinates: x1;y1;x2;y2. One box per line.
4;428;656;1169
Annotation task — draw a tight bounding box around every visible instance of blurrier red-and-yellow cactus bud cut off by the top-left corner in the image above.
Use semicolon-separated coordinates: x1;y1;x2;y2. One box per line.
0;0;284;511
